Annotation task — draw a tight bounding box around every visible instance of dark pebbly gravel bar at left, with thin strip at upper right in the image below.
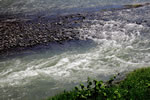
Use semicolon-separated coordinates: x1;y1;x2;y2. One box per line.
0;3;149;53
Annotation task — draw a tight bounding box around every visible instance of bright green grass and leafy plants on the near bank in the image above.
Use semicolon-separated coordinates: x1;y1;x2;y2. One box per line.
48;68;150;100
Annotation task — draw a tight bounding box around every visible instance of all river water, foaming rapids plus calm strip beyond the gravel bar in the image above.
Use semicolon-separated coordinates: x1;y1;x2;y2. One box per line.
0;0;150;100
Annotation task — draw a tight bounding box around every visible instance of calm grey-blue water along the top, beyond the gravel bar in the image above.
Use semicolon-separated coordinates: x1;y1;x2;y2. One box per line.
0;0;150;15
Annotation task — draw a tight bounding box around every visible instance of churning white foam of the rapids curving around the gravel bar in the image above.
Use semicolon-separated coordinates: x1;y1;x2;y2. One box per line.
0;7;150;88
